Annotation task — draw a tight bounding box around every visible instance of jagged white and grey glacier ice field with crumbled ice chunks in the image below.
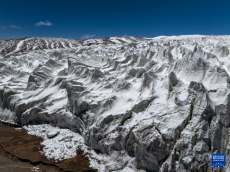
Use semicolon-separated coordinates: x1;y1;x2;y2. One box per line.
0;35;230;172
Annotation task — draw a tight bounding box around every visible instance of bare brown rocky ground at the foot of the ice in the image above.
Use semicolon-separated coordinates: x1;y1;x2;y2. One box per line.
0;123;97;172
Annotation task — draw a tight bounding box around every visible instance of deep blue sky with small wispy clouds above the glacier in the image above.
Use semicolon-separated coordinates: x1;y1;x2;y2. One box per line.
0;0;230;39
